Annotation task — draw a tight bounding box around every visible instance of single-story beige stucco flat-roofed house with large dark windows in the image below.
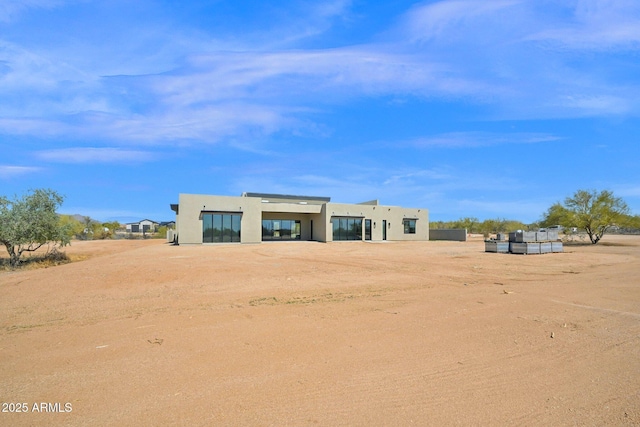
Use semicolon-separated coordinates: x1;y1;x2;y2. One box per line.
171;193;429;244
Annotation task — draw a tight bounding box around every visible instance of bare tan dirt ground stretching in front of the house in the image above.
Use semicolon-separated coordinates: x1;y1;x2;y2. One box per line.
0;236;640;426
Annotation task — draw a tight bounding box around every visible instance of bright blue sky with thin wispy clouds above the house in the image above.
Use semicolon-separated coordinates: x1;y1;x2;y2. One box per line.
0;0;640;222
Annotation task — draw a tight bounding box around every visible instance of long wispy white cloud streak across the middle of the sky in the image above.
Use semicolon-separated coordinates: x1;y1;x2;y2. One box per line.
154;46;456;106
